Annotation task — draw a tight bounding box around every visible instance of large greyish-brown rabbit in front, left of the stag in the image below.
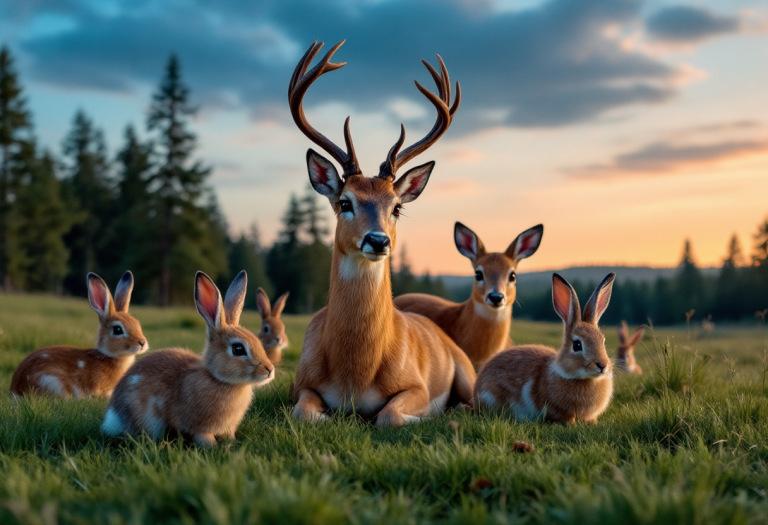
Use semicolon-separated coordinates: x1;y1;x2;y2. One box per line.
101;271;275;446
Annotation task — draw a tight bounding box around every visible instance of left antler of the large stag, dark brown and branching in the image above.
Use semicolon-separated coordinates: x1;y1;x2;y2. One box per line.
288;40;362;177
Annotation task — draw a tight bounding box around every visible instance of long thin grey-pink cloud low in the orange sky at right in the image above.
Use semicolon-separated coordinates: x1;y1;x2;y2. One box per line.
565;135;768;178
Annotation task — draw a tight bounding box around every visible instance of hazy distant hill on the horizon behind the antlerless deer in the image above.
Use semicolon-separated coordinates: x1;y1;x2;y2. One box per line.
438;266;720;297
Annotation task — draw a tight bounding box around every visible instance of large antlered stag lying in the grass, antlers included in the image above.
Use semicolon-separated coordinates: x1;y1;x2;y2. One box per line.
288;41;475;427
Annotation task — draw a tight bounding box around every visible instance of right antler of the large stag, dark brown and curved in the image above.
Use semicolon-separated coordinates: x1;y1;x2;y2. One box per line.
379;55;461;180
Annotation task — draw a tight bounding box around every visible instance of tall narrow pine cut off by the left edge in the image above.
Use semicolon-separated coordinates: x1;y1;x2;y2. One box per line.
0;46;32;292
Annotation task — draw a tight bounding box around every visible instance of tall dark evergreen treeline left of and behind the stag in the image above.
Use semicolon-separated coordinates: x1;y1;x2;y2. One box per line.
0;47;444;312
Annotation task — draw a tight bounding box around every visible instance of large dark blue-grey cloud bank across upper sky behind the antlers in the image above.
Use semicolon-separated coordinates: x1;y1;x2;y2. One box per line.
6;0;704;133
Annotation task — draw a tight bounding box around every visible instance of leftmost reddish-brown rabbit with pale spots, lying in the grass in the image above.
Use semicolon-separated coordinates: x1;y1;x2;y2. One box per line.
11;272;149;399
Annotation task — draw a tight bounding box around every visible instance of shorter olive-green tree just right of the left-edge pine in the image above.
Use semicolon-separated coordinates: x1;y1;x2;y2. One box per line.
13;144;72;293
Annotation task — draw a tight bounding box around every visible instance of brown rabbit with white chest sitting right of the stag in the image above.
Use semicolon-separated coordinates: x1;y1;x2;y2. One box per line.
473;273;616;423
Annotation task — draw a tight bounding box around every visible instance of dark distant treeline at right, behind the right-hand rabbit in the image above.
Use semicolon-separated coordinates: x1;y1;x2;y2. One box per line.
515;233;768;325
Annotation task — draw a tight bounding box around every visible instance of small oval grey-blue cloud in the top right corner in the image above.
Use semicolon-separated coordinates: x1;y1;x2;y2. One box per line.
646;5;741;44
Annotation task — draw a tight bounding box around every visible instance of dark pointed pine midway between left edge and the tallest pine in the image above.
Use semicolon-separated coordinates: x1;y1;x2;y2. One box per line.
62;110;114;295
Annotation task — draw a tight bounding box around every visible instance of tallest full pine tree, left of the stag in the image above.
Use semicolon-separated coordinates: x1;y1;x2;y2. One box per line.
147;55;226;306
